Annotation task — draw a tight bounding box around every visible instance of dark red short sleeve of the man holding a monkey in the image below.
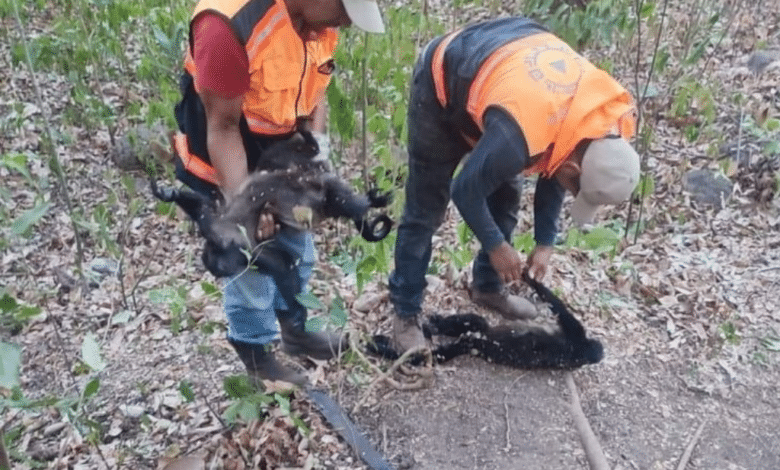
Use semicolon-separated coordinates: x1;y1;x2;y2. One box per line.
192;13;249;99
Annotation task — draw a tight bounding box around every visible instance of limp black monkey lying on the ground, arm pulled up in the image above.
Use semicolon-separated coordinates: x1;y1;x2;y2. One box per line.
369;273;604;369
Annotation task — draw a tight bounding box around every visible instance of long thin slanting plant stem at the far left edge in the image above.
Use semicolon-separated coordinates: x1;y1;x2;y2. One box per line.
13;0;84;282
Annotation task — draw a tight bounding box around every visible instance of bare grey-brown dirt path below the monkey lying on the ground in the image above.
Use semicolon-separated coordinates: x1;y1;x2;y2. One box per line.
350;318;780;470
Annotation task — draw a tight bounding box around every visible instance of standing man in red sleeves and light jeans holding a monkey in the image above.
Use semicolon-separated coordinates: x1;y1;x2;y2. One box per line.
174;0;384;385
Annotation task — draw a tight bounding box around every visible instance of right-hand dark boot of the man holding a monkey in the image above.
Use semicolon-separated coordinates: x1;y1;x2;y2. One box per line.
279;318;349;359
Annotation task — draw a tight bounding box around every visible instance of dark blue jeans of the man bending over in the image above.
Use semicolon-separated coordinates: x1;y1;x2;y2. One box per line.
389;44;521;317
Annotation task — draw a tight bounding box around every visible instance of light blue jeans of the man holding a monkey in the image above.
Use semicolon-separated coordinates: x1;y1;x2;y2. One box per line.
222;229;315;345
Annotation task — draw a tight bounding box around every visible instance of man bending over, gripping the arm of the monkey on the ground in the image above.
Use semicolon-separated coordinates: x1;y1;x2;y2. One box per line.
389;18;639;351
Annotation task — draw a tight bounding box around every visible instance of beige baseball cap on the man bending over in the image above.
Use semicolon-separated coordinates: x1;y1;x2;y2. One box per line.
571;137;639;226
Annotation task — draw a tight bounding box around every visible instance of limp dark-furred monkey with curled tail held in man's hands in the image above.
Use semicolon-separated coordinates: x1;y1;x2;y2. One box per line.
152;134;392;277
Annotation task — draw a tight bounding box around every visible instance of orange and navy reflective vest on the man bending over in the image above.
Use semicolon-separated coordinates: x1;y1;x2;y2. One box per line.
431;18;636;177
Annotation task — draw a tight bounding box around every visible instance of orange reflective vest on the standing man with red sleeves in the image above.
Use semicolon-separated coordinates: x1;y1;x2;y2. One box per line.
174;0;338;184
